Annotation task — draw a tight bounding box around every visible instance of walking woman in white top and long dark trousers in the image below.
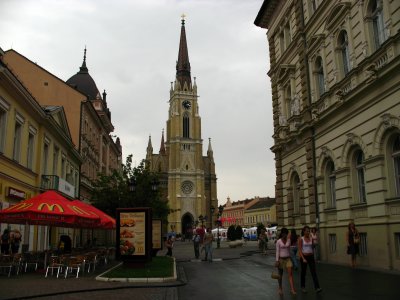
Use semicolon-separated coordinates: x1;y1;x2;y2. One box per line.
298;226;322;293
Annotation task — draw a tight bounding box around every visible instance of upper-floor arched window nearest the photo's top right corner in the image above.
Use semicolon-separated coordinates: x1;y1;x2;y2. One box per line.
368;0;385;50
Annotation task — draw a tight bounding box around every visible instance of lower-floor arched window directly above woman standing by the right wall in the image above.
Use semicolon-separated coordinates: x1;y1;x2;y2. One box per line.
352;149;367;203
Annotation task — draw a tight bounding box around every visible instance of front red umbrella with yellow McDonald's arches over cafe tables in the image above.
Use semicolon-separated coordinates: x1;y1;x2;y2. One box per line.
0;191;100;228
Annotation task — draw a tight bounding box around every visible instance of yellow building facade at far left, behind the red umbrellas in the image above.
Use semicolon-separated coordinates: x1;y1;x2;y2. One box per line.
0;50;82;250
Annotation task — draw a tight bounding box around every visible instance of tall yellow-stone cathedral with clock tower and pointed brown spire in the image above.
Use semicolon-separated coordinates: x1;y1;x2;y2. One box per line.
146;19;218;234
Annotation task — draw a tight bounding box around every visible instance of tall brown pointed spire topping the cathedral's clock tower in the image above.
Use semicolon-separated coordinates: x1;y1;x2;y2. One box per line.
176;14;191;89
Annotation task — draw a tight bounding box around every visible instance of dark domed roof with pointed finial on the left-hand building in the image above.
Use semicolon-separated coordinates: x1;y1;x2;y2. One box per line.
67;48;101;100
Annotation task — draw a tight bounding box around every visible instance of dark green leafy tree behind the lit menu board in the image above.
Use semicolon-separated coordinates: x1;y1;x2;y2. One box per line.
92;155;169;222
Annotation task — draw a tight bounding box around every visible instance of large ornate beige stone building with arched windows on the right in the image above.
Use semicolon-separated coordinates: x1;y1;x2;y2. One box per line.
255;0;400;270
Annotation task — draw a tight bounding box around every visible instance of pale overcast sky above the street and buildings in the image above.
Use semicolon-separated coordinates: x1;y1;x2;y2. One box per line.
0;0;275;204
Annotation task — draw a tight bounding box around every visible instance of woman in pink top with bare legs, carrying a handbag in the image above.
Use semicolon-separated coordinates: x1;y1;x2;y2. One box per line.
275;227;296;295
